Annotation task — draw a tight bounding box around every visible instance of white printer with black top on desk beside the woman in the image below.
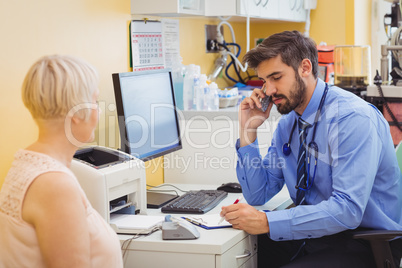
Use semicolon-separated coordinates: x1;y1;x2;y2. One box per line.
71;146;147;230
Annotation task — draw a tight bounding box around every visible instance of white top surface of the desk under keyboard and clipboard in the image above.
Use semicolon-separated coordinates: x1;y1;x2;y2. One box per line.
119;184;291;254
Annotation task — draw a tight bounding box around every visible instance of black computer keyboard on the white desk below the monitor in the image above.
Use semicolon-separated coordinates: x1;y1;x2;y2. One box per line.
161;190;228;214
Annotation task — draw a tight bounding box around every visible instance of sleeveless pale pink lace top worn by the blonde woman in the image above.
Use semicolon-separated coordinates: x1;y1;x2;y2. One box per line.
0;150;123;268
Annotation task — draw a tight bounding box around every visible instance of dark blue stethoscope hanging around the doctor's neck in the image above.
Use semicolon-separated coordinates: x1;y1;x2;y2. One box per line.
282;83;328;191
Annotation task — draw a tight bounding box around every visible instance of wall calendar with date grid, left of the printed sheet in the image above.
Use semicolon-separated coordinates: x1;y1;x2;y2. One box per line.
131;20;165;71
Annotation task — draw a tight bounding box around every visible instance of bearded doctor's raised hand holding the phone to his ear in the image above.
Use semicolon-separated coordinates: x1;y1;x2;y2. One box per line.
239;85;273;147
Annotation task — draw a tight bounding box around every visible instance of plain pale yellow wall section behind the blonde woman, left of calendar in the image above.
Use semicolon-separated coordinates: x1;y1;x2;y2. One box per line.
0;0;131;185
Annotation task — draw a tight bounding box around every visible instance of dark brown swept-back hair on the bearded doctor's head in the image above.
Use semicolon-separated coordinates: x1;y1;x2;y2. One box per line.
243;31;318;78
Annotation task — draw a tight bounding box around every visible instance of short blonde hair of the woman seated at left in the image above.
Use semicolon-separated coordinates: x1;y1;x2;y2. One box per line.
22;55;99;119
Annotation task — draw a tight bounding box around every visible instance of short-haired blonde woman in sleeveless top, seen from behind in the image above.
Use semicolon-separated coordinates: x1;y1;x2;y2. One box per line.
0;55;122;268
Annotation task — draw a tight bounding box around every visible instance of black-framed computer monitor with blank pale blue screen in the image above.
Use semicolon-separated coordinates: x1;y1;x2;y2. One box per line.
112;70;182;161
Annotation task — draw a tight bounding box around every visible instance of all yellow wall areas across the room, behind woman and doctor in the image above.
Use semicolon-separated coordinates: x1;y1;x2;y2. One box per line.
0;0;370;188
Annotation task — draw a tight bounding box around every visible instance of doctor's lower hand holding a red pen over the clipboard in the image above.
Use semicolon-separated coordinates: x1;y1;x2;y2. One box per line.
220;203;269;235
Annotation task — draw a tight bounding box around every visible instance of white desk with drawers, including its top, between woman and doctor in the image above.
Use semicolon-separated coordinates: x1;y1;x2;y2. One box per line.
119;184;291;268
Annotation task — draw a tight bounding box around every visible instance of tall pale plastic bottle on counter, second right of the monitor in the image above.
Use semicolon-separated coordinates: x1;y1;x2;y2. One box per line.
183;64;200;110
